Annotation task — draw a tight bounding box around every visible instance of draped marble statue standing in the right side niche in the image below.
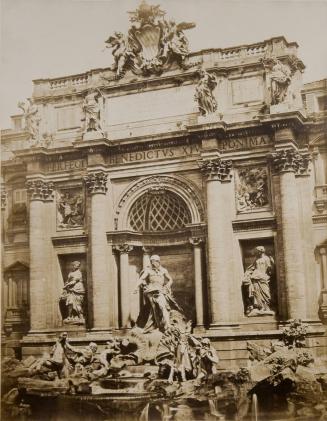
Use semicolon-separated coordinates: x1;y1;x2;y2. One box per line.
242;246;274;317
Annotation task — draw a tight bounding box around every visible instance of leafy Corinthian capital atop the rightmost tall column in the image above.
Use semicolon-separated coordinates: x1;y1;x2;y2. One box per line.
269;149;311;175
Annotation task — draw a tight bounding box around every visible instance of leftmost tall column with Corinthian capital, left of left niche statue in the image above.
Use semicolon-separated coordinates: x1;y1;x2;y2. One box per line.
26;179;53;332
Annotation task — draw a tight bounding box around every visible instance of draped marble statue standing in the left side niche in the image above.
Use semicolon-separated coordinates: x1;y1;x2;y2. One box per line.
59;260;85;325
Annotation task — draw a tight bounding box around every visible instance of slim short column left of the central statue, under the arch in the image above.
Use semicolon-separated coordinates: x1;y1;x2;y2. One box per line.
115;244;133;327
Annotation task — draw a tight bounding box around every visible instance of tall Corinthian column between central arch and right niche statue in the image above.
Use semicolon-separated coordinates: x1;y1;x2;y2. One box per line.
199;157;234;327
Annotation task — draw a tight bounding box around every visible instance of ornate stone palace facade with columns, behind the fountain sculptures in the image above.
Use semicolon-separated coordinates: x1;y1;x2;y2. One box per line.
1;2;327;367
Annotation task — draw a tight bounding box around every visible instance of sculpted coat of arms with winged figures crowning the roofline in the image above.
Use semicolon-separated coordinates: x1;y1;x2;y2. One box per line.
106;1;195;78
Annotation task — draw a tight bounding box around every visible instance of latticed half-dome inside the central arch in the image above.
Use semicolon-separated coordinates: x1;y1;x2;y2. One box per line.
129;190;191;232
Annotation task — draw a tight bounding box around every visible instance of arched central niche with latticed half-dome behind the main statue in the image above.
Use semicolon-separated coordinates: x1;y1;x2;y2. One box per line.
113;176;204;320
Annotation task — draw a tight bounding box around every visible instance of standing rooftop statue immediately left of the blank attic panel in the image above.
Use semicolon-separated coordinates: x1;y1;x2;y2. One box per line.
82;89;102;133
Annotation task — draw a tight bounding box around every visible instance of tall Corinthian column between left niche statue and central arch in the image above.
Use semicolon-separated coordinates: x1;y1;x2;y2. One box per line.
84;171;111;330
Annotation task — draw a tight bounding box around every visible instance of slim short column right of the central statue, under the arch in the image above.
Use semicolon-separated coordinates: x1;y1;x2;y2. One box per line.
190;238;203;326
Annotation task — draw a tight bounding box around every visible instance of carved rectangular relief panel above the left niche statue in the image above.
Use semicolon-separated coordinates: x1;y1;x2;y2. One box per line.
57;189;85;229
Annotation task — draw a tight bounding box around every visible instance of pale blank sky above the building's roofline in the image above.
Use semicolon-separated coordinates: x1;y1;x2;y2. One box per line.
0;0;327;128
